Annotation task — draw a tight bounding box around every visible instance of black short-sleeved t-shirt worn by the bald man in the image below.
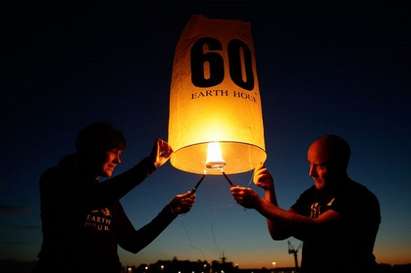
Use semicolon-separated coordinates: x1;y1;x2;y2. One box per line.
291;180;381;273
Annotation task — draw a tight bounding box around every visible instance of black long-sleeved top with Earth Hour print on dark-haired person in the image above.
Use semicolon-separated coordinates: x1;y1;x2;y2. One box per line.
34;156;175;273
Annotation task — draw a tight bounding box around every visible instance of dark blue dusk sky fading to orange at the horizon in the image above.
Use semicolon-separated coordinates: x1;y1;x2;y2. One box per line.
0;0;411;268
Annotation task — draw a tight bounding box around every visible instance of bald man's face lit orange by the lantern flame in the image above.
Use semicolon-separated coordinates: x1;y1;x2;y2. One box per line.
307;141;338;190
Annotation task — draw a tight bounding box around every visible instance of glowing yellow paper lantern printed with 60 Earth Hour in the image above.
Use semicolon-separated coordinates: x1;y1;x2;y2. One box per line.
168;15;266;174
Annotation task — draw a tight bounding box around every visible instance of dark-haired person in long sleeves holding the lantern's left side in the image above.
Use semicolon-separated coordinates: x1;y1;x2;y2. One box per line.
34;123;195;273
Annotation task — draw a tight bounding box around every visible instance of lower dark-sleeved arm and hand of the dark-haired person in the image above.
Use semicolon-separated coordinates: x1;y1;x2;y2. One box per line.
118;192;195;253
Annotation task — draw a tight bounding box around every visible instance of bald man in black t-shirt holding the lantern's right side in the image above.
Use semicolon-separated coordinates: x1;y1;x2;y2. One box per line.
231;135;381;273
